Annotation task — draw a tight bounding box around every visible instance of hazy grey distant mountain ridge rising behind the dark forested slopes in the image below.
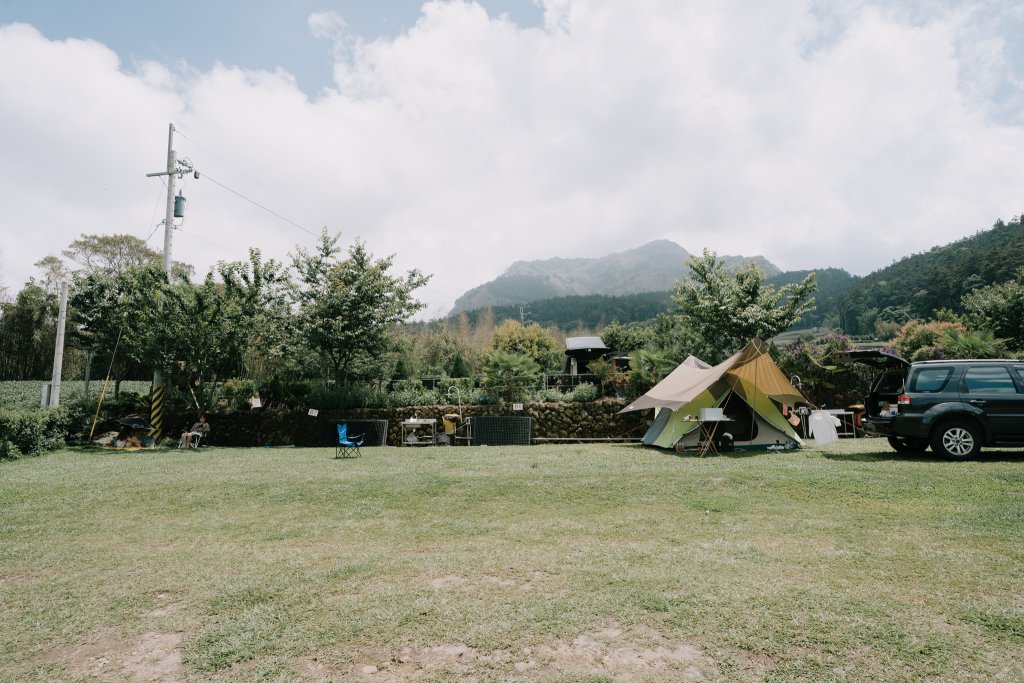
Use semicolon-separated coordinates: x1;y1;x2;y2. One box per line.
450;240;780;314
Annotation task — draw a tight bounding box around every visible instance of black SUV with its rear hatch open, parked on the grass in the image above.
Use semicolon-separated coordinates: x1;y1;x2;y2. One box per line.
837;351;1024;459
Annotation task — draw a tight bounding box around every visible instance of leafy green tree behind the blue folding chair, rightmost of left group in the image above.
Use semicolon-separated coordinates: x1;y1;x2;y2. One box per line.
292;229;430;385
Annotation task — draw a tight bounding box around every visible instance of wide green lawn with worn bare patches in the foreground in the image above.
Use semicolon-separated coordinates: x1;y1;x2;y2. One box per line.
0;439;1024;681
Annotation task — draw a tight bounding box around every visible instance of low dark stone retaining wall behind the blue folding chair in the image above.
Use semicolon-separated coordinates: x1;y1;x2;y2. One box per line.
165;400;651;446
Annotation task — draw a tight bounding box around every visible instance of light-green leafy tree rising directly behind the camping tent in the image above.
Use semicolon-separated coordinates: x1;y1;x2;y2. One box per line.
672;249;816;365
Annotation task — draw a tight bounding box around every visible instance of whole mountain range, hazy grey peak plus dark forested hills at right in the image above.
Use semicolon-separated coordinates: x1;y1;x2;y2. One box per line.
444;216;1024;335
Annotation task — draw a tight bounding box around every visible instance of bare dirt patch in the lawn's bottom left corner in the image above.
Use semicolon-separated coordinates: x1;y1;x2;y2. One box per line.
56;631;185;683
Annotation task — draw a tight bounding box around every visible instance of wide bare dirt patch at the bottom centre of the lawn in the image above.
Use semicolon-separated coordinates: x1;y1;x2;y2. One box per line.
313;624;720;683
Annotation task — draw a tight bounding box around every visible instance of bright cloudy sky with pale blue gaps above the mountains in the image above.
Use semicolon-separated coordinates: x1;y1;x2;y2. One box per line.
0;0;1024;317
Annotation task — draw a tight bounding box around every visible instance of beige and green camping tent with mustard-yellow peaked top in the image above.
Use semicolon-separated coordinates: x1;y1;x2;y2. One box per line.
622;339;807;449
